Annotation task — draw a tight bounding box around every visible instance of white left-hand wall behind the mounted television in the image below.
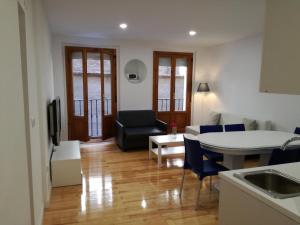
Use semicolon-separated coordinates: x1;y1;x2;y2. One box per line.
0;0;53;225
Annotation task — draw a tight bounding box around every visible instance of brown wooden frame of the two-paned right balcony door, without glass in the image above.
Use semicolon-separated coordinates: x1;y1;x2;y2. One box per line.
152;51;194;132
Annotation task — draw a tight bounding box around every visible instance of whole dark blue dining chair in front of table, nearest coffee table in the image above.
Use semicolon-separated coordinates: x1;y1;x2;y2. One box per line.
179;136;227;209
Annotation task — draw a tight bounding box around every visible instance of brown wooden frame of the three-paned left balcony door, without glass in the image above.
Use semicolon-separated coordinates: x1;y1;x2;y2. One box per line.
65;46;117;141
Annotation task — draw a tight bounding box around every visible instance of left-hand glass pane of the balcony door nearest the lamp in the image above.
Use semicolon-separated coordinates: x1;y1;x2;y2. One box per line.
157;57;171;112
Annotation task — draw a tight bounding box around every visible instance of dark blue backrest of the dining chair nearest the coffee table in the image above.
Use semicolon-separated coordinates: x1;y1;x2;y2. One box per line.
183;136;203;176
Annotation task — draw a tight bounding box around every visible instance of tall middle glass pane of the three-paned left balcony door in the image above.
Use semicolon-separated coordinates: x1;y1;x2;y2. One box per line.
87;52;102;137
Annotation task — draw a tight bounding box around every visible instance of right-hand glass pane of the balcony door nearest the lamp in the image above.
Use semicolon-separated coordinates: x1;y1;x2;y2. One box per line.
174;58;188;112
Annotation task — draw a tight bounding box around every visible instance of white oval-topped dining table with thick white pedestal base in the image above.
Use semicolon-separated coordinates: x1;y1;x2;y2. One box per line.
197;130;300;169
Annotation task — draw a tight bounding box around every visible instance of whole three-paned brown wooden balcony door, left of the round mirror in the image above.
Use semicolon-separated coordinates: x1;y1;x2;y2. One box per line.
65;46;117;141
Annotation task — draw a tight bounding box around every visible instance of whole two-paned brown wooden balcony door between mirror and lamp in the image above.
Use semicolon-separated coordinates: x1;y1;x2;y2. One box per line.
153;51;193;132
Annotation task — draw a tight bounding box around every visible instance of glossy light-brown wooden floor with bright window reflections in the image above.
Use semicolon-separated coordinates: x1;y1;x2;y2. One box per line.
44;141;258;225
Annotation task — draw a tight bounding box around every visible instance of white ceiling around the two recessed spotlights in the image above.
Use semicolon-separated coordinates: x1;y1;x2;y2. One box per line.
44;0;265;45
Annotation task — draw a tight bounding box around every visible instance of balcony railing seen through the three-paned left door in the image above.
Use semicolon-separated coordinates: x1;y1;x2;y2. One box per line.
74;98;111;137
